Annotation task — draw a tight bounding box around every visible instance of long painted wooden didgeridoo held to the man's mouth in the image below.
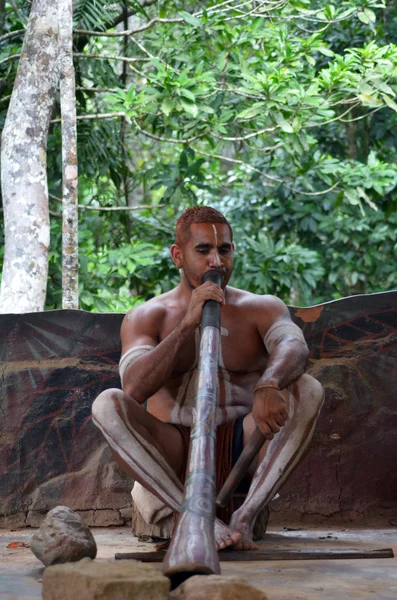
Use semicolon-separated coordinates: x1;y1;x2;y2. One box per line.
163;271;222;589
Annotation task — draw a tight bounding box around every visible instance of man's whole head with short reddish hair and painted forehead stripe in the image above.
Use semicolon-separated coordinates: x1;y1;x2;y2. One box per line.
171;206;234;288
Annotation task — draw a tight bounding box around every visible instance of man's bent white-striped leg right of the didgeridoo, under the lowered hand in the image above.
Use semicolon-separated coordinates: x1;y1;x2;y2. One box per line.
230;374;324;550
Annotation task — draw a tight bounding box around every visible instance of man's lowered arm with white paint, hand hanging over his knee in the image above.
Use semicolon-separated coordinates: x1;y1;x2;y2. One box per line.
252;297;309;440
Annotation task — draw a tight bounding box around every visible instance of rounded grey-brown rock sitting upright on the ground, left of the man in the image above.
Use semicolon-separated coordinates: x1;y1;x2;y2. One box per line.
30;506;97;566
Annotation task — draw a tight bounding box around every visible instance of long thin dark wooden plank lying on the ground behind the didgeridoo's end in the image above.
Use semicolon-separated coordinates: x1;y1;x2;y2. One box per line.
115;548;394;562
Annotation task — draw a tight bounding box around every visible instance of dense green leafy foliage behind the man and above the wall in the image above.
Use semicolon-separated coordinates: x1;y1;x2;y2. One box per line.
0;0;397;311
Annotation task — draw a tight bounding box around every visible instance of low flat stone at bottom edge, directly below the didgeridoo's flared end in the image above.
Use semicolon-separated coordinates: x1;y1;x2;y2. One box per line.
170;575;267;600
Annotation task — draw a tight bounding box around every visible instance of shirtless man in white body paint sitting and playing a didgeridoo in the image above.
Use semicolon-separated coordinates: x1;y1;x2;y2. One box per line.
93;207;323;550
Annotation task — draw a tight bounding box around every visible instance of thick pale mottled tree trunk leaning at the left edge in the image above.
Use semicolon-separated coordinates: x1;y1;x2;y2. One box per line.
0;0;58;313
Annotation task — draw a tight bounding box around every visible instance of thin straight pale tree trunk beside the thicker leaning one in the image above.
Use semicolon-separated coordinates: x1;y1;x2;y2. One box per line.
58;0;79;309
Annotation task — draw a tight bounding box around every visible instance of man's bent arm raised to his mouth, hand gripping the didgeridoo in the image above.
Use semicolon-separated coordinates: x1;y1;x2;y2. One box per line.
120;282;224;403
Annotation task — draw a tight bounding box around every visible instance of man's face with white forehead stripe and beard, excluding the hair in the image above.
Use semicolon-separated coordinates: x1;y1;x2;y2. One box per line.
173;223;234;288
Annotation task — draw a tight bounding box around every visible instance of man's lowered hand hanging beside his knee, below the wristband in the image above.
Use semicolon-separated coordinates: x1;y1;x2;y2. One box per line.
252;388;288;440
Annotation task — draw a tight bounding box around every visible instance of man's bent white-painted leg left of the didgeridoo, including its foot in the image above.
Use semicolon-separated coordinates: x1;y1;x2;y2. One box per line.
92;389;242;549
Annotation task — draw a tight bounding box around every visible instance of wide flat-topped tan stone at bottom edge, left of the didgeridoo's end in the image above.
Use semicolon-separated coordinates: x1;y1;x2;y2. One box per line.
43;558;170;600
